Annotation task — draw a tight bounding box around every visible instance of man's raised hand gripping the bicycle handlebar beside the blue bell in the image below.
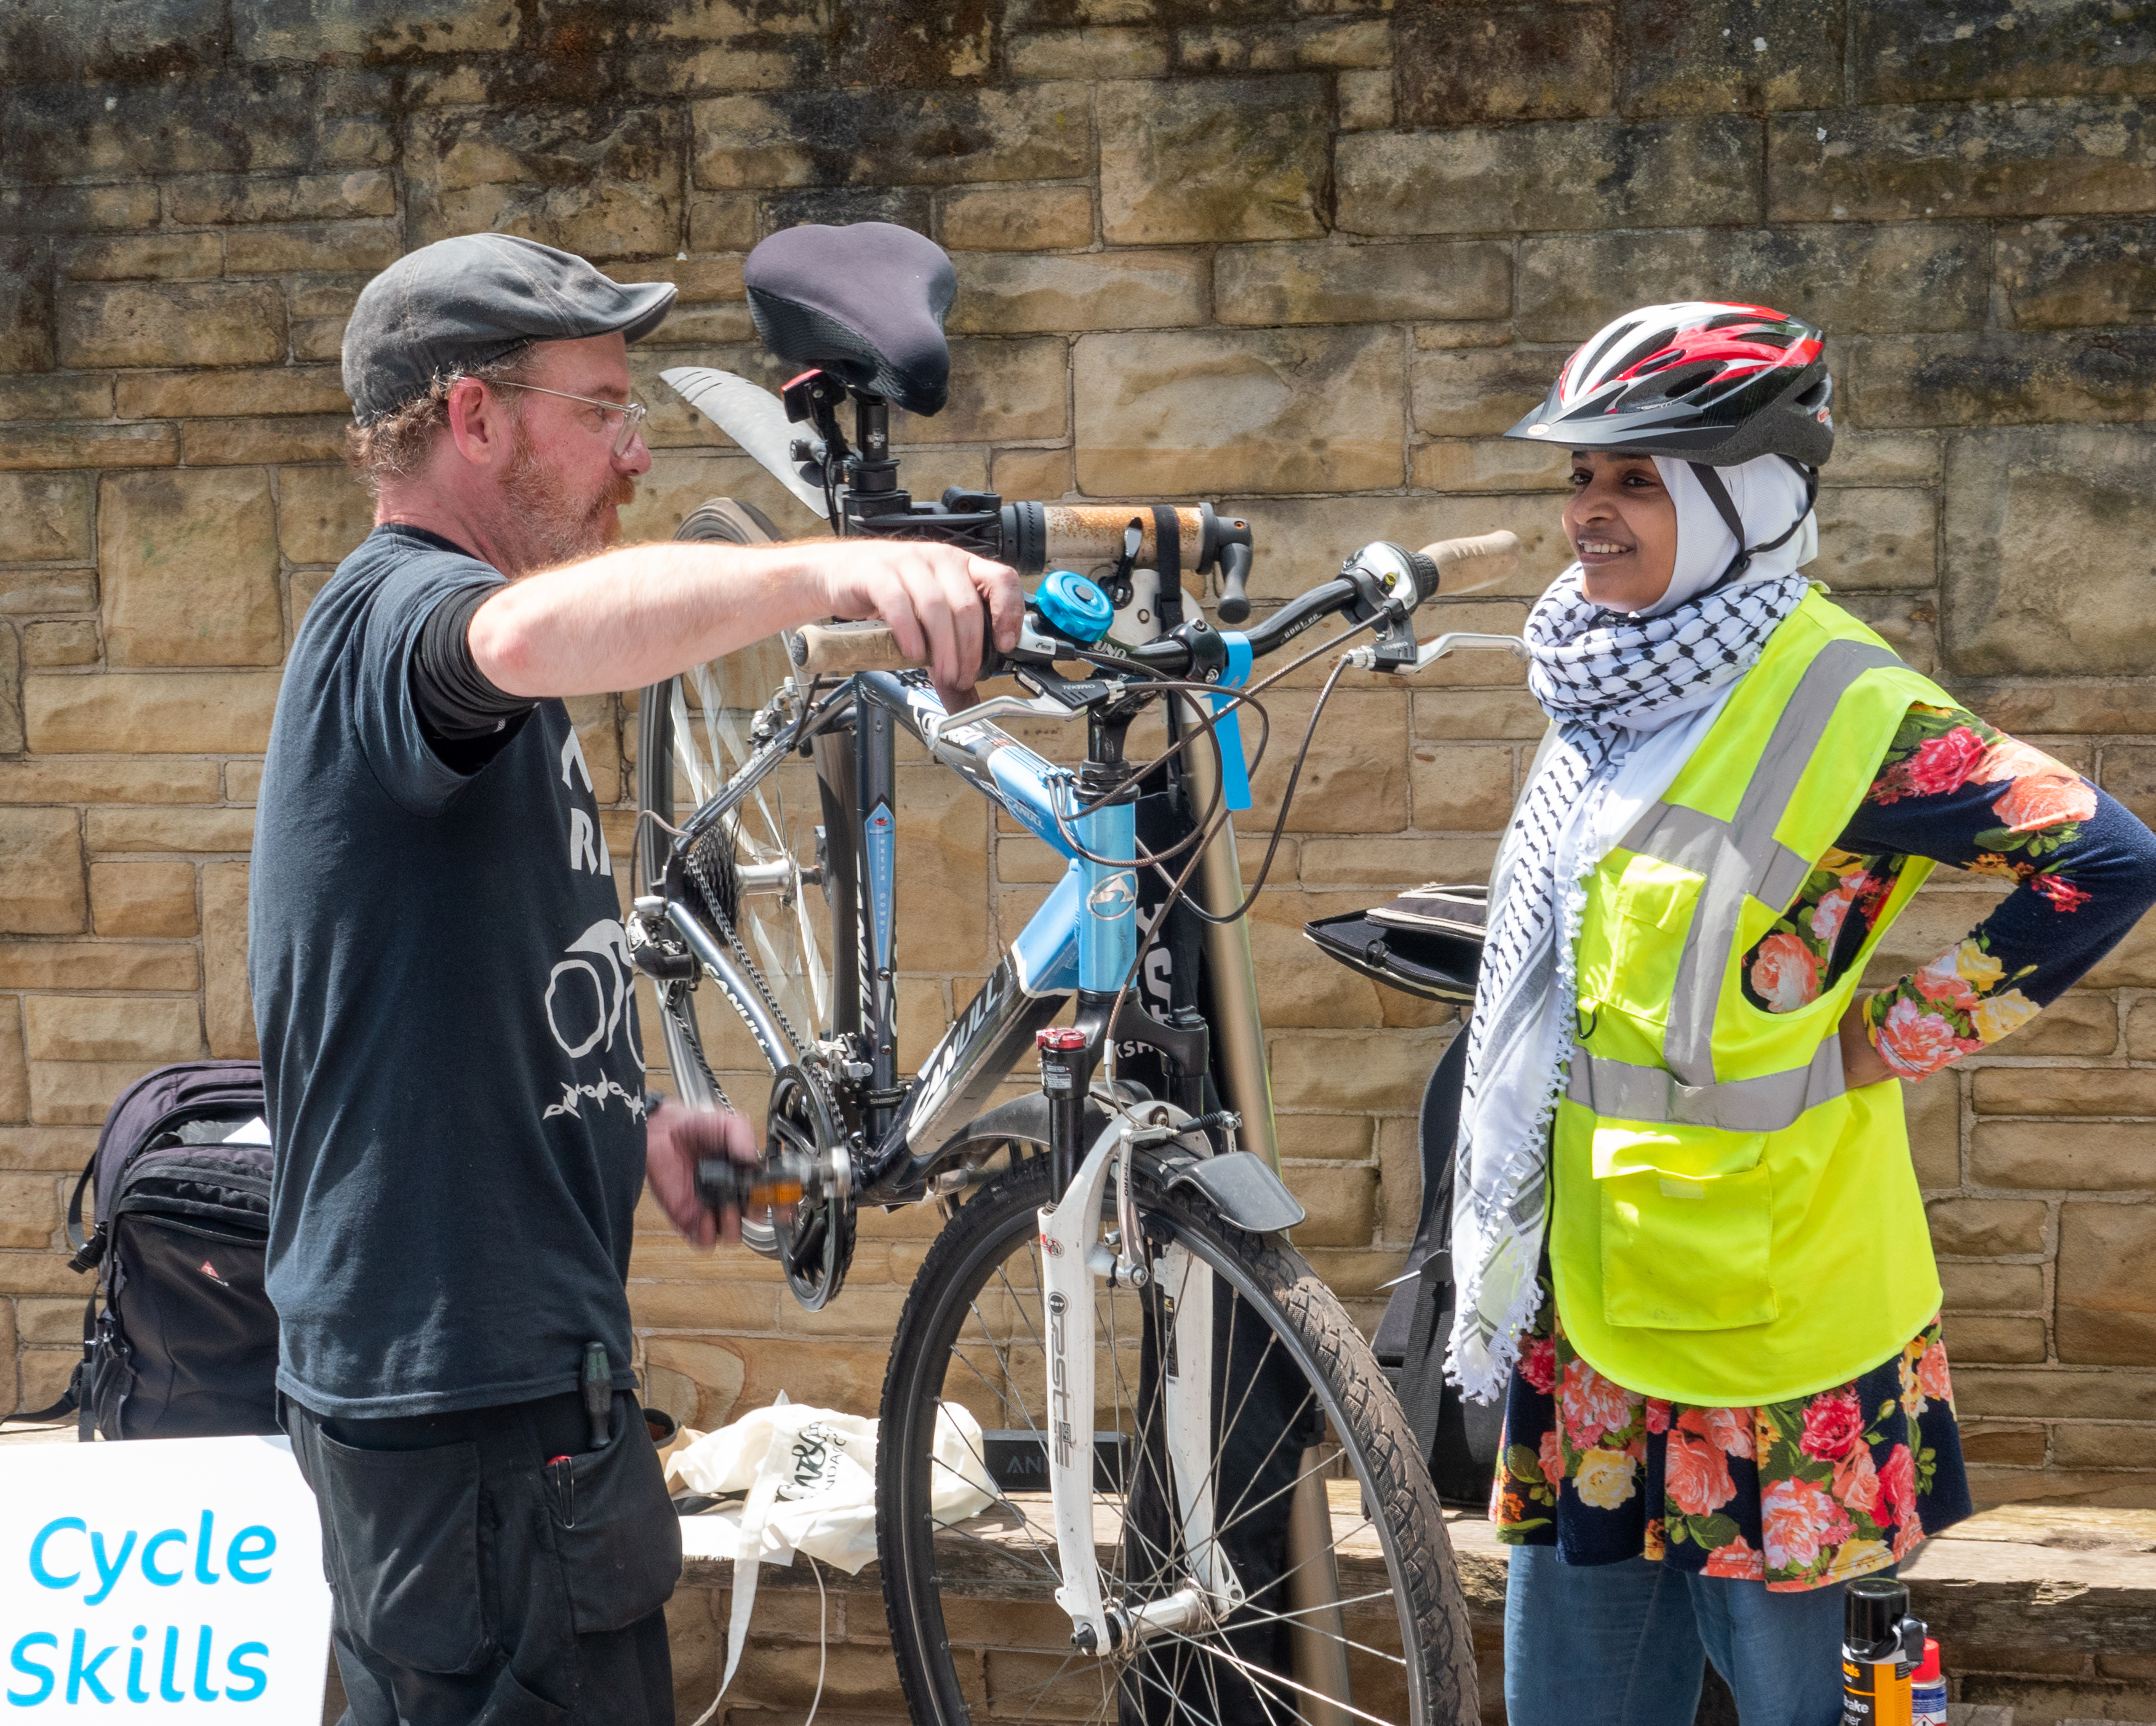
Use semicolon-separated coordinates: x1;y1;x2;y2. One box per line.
817;538;1026;711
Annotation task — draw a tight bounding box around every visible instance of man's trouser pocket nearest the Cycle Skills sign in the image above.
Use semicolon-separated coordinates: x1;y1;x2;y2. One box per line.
306;1429;493;1672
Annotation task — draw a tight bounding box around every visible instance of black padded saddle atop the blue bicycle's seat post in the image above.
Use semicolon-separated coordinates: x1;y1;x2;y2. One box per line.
741;222;957;414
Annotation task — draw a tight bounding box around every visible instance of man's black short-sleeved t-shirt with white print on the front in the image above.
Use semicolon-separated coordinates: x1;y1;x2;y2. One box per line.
248;528;645;1416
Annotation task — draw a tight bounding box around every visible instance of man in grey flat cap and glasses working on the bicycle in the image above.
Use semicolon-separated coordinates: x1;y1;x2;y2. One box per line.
250;235;1020;1726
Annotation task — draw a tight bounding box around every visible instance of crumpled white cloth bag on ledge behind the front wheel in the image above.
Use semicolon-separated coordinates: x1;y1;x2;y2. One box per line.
671;1392;996;1706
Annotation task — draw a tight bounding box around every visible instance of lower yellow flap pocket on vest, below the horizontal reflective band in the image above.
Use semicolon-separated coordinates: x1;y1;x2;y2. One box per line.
1593;1125;1776;1330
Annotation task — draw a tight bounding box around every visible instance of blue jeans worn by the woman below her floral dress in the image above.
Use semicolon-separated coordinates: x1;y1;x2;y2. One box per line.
1505;1547;1841;1726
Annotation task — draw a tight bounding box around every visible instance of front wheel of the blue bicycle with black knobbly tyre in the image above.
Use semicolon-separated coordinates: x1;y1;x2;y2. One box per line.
877;1157;1477;1726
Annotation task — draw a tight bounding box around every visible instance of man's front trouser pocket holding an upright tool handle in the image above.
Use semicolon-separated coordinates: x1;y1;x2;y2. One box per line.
546;1396;681;1636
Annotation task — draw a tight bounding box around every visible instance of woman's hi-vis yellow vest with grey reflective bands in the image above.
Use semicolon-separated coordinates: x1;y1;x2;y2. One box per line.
1550;593;1954;1407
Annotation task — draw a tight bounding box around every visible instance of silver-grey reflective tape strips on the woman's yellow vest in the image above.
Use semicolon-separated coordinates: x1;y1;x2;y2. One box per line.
1565;640;1902;1133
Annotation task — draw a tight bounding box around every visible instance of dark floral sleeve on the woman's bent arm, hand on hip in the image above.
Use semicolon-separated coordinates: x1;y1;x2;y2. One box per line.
1744;705;2156;1079
